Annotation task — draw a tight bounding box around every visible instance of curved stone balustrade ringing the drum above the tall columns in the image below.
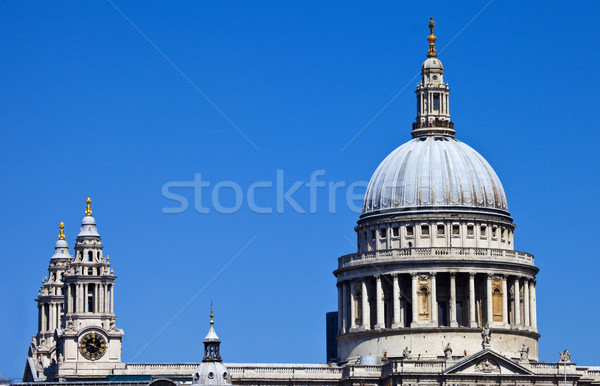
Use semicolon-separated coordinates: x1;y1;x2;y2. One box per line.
338;247;533;269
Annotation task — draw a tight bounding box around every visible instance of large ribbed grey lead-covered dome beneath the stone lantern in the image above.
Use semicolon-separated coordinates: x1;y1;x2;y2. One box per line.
361;135;509;217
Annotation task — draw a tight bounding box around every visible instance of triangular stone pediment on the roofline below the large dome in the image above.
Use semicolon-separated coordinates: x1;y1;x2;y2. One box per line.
444;349;533;375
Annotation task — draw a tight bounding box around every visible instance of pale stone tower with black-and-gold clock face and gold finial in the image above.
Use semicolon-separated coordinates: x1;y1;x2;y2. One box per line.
57;197;125;380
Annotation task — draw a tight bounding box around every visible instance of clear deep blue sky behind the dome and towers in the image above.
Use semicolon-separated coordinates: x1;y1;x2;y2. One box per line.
0;0;600;377
